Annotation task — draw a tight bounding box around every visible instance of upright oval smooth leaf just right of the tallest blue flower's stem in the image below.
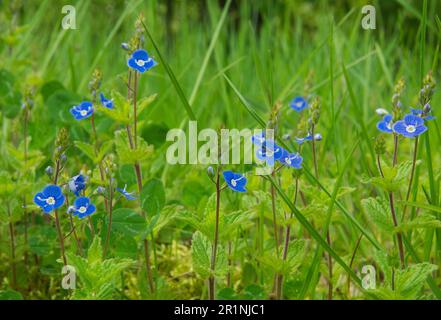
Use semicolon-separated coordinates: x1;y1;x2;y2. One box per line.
141;179;165;216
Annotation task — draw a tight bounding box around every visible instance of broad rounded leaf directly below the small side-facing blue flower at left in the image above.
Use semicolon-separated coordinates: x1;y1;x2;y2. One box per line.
112;208;147;237
